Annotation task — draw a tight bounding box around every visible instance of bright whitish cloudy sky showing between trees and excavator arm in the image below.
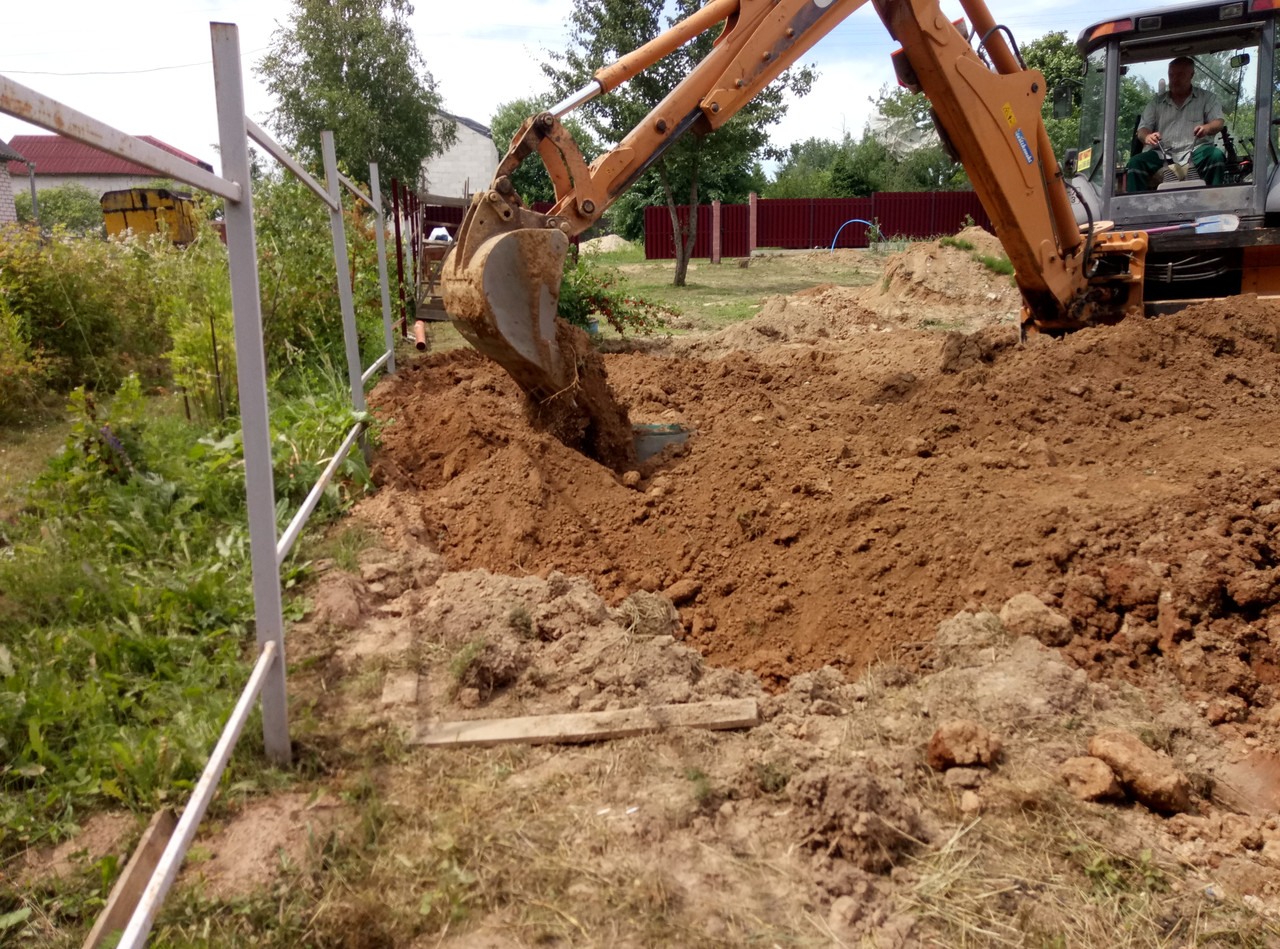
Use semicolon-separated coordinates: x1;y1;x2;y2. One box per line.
0;0;1146;179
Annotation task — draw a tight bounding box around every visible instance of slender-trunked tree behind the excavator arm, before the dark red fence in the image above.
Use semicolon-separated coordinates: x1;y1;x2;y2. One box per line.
543;0;814;287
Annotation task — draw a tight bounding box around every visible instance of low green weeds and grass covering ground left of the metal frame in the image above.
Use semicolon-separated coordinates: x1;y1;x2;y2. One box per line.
0;378;367;860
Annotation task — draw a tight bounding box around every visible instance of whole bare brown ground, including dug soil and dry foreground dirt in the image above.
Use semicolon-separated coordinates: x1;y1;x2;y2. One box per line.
20;245;1280;949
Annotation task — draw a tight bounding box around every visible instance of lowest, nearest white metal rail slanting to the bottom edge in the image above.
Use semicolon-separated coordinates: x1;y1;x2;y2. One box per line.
116;642;276;949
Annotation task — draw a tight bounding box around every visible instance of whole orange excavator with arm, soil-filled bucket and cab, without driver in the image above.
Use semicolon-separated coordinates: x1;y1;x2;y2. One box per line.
442;0;1280;469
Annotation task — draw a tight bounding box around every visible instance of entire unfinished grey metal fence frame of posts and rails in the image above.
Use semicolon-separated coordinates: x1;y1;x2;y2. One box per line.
0;23;396;949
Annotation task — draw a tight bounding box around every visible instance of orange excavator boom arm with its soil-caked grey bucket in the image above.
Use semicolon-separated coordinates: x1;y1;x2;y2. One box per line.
442;0;1146;466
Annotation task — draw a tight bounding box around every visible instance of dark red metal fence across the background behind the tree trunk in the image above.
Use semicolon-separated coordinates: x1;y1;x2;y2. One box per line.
644;191;991;260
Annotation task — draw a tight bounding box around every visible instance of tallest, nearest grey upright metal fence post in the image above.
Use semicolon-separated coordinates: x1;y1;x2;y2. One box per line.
210;23;292;765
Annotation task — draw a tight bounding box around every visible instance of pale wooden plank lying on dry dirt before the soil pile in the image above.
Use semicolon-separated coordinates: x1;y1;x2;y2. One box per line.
410;698;760;745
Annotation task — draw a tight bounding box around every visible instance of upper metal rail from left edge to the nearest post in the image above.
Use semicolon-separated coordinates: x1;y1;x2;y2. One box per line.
0;76;243;201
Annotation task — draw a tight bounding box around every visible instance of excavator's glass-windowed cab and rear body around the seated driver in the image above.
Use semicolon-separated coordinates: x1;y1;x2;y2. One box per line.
1071;0;1280;295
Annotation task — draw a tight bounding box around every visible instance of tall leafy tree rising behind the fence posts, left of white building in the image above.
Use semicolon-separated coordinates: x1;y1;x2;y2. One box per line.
257;0;454;184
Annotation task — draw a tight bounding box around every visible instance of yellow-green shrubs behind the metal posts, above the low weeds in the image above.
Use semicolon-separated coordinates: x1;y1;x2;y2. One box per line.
0;170;383;407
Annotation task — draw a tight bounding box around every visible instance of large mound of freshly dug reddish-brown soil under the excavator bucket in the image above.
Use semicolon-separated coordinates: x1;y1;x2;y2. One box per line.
372;297;1280;713
